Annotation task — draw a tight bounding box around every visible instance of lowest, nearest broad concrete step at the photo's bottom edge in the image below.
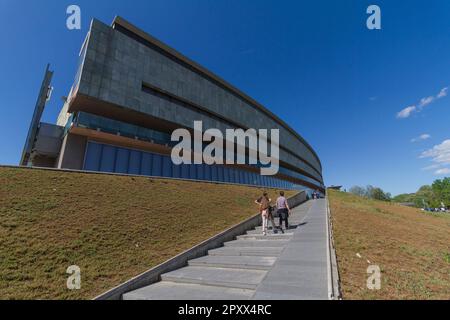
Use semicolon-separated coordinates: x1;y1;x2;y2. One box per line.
123;281;255;300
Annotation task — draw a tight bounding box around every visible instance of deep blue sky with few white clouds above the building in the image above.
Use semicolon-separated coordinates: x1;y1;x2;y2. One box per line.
0;0;450;194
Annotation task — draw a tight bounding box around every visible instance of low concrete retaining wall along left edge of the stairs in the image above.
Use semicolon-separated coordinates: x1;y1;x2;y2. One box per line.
94;191;307;300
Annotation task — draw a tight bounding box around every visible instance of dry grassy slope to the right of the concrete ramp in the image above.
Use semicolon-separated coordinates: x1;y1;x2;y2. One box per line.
329;191;450;299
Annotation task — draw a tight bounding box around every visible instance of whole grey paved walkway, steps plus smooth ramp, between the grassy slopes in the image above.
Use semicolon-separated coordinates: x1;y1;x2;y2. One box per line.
123;200;328;300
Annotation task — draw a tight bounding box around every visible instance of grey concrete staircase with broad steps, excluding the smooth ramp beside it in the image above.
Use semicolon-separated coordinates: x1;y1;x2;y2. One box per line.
123;202;311;300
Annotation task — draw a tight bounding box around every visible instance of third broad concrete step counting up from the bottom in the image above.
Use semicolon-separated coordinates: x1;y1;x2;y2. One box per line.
189;256;277;270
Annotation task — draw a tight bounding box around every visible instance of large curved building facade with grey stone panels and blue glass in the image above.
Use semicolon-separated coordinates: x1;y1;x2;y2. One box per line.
25;17;324;191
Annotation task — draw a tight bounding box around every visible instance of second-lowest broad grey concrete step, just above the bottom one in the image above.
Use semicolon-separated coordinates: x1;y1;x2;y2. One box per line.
161;266;267;290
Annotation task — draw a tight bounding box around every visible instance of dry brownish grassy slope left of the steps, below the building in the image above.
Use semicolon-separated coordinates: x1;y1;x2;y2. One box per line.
0;168;293;299
